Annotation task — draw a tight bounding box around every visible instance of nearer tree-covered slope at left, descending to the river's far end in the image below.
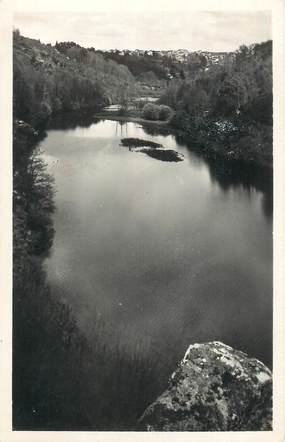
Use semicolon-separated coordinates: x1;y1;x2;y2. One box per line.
13;31;134;126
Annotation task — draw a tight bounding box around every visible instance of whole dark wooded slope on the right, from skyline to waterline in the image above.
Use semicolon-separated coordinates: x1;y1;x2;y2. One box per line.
160;41;272;166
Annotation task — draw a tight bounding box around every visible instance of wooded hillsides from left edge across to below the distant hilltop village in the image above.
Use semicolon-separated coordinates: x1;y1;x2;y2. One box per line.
13;31;240;127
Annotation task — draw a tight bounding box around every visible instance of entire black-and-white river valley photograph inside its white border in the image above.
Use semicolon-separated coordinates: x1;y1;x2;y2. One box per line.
0;1;281;442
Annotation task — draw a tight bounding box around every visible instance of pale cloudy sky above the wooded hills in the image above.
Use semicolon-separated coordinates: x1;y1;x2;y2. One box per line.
13;10;272;51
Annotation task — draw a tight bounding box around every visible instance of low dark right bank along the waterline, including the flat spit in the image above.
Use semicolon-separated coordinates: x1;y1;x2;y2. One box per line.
92;111;273;175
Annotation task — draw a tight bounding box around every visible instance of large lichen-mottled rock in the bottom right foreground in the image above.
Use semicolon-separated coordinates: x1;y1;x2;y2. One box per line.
139;342;272;431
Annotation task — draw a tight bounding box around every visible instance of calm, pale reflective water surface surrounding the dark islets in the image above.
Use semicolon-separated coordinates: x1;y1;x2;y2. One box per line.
38;121;272;370
